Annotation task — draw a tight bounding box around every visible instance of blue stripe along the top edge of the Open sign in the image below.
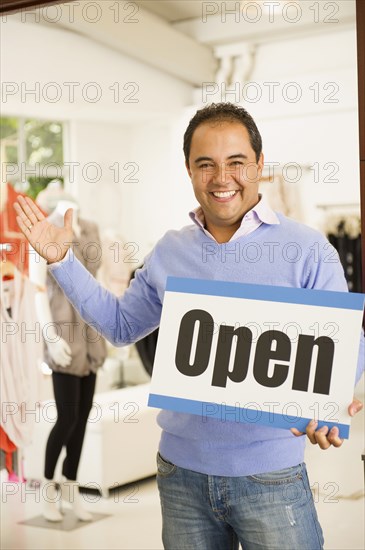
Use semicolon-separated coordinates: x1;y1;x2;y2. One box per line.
166;277;365;311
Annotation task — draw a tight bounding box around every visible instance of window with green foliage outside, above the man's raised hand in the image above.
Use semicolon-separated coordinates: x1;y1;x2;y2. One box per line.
0;117;65;198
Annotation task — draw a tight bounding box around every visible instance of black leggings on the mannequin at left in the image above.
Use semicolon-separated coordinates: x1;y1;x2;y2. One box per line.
44;372;96;481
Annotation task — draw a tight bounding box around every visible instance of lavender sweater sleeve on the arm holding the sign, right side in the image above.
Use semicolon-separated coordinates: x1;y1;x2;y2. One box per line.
305;237;365;385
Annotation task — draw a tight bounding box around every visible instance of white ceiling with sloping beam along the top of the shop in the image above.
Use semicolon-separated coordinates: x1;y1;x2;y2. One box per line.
1;0;356;87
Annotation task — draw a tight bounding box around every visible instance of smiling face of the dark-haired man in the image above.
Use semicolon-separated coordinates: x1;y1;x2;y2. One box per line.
187;122;263;242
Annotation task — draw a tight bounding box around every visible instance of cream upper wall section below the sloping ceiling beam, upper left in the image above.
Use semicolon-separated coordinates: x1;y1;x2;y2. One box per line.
1;16;191;122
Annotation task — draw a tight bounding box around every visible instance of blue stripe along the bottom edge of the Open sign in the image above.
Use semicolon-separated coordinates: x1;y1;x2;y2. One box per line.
148;393;350;439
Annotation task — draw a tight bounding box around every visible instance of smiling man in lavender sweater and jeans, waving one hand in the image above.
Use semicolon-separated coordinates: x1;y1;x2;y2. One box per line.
15;104;364;550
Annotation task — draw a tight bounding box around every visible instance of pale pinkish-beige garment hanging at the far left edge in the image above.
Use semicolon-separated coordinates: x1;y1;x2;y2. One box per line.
0;269;43;447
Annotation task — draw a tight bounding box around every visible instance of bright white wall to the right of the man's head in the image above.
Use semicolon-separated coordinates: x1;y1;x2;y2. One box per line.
253;29;360;220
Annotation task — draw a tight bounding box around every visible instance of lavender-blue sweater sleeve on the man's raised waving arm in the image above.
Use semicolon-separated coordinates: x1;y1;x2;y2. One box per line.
49;250;162;346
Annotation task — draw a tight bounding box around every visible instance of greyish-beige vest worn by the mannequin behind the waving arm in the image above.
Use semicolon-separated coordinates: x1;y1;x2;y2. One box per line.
45;213;106;376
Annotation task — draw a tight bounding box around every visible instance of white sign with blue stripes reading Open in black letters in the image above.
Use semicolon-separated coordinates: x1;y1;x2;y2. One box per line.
148;277;365;438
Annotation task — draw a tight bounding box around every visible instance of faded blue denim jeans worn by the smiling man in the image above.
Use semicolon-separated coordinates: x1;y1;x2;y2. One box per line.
157;453;323;550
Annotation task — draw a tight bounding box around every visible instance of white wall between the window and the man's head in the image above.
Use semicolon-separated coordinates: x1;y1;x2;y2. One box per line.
70;117;195;262
